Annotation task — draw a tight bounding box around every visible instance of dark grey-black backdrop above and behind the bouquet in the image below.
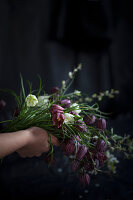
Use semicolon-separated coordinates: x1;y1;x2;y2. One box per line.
0;0;133;114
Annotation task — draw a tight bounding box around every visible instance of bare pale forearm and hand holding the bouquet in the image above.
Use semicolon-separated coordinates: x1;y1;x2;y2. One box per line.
0;127;59;158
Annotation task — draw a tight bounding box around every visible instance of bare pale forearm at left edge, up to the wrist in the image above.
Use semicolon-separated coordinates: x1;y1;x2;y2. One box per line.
0;130;29;158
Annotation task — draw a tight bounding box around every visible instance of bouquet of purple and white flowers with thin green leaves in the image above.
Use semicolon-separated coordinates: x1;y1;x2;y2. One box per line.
1;64;133;185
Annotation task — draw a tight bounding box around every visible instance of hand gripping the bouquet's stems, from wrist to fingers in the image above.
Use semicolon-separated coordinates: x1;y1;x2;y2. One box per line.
17;127;59;158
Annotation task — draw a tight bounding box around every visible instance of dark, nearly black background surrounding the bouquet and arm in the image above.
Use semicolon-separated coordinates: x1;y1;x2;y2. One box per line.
0;0;133;199
